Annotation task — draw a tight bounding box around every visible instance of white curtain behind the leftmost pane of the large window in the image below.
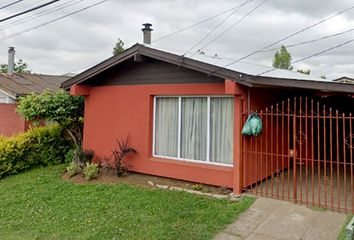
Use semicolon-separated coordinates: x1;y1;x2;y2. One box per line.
155;97;178;157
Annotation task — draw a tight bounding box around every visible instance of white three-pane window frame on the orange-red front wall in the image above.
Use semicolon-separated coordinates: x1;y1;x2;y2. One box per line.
152;95;235;167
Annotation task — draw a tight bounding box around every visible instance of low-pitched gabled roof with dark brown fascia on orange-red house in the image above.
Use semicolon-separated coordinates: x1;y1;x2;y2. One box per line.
62;44;354;93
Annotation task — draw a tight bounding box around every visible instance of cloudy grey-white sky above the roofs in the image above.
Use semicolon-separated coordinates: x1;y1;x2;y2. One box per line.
0;0;354;78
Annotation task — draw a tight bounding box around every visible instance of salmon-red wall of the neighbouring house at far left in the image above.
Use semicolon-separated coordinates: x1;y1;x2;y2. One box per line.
0;103;26;136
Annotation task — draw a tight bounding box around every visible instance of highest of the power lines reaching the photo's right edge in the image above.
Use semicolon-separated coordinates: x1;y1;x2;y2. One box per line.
223;5;354;67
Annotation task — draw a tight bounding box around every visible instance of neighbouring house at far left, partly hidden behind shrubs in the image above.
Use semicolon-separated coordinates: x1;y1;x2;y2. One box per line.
0;47;69;136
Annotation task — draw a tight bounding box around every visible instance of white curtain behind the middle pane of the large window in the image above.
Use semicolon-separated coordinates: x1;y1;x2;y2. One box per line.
181;97;208;161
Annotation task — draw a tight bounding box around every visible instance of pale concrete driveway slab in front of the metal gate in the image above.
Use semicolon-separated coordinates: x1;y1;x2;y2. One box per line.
214;198;346;240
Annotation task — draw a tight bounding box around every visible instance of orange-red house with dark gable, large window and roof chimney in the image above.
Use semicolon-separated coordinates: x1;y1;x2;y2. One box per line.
62;25;354;212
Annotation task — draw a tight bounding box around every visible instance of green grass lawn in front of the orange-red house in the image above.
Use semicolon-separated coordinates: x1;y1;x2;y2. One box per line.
0;165;254;240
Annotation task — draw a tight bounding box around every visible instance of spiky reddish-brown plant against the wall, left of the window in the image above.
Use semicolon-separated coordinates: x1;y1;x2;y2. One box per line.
104;138;137;177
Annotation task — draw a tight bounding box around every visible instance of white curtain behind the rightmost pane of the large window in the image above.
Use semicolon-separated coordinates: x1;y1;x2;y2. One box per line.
210;98;234;164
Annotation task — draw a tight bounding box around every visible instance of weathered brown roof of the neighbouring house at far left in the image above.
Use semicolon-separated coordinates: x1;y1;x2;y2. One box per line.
0;73;70;98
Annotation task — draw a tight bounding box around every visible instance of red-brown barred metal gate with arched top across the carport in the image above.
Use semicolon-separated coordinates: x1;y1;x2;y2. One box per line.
242;97;354;213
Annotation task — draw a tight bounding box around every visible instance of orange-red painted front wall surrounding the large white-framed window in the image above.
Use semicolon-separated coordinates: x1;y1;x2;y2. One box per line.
80;83;246;188
